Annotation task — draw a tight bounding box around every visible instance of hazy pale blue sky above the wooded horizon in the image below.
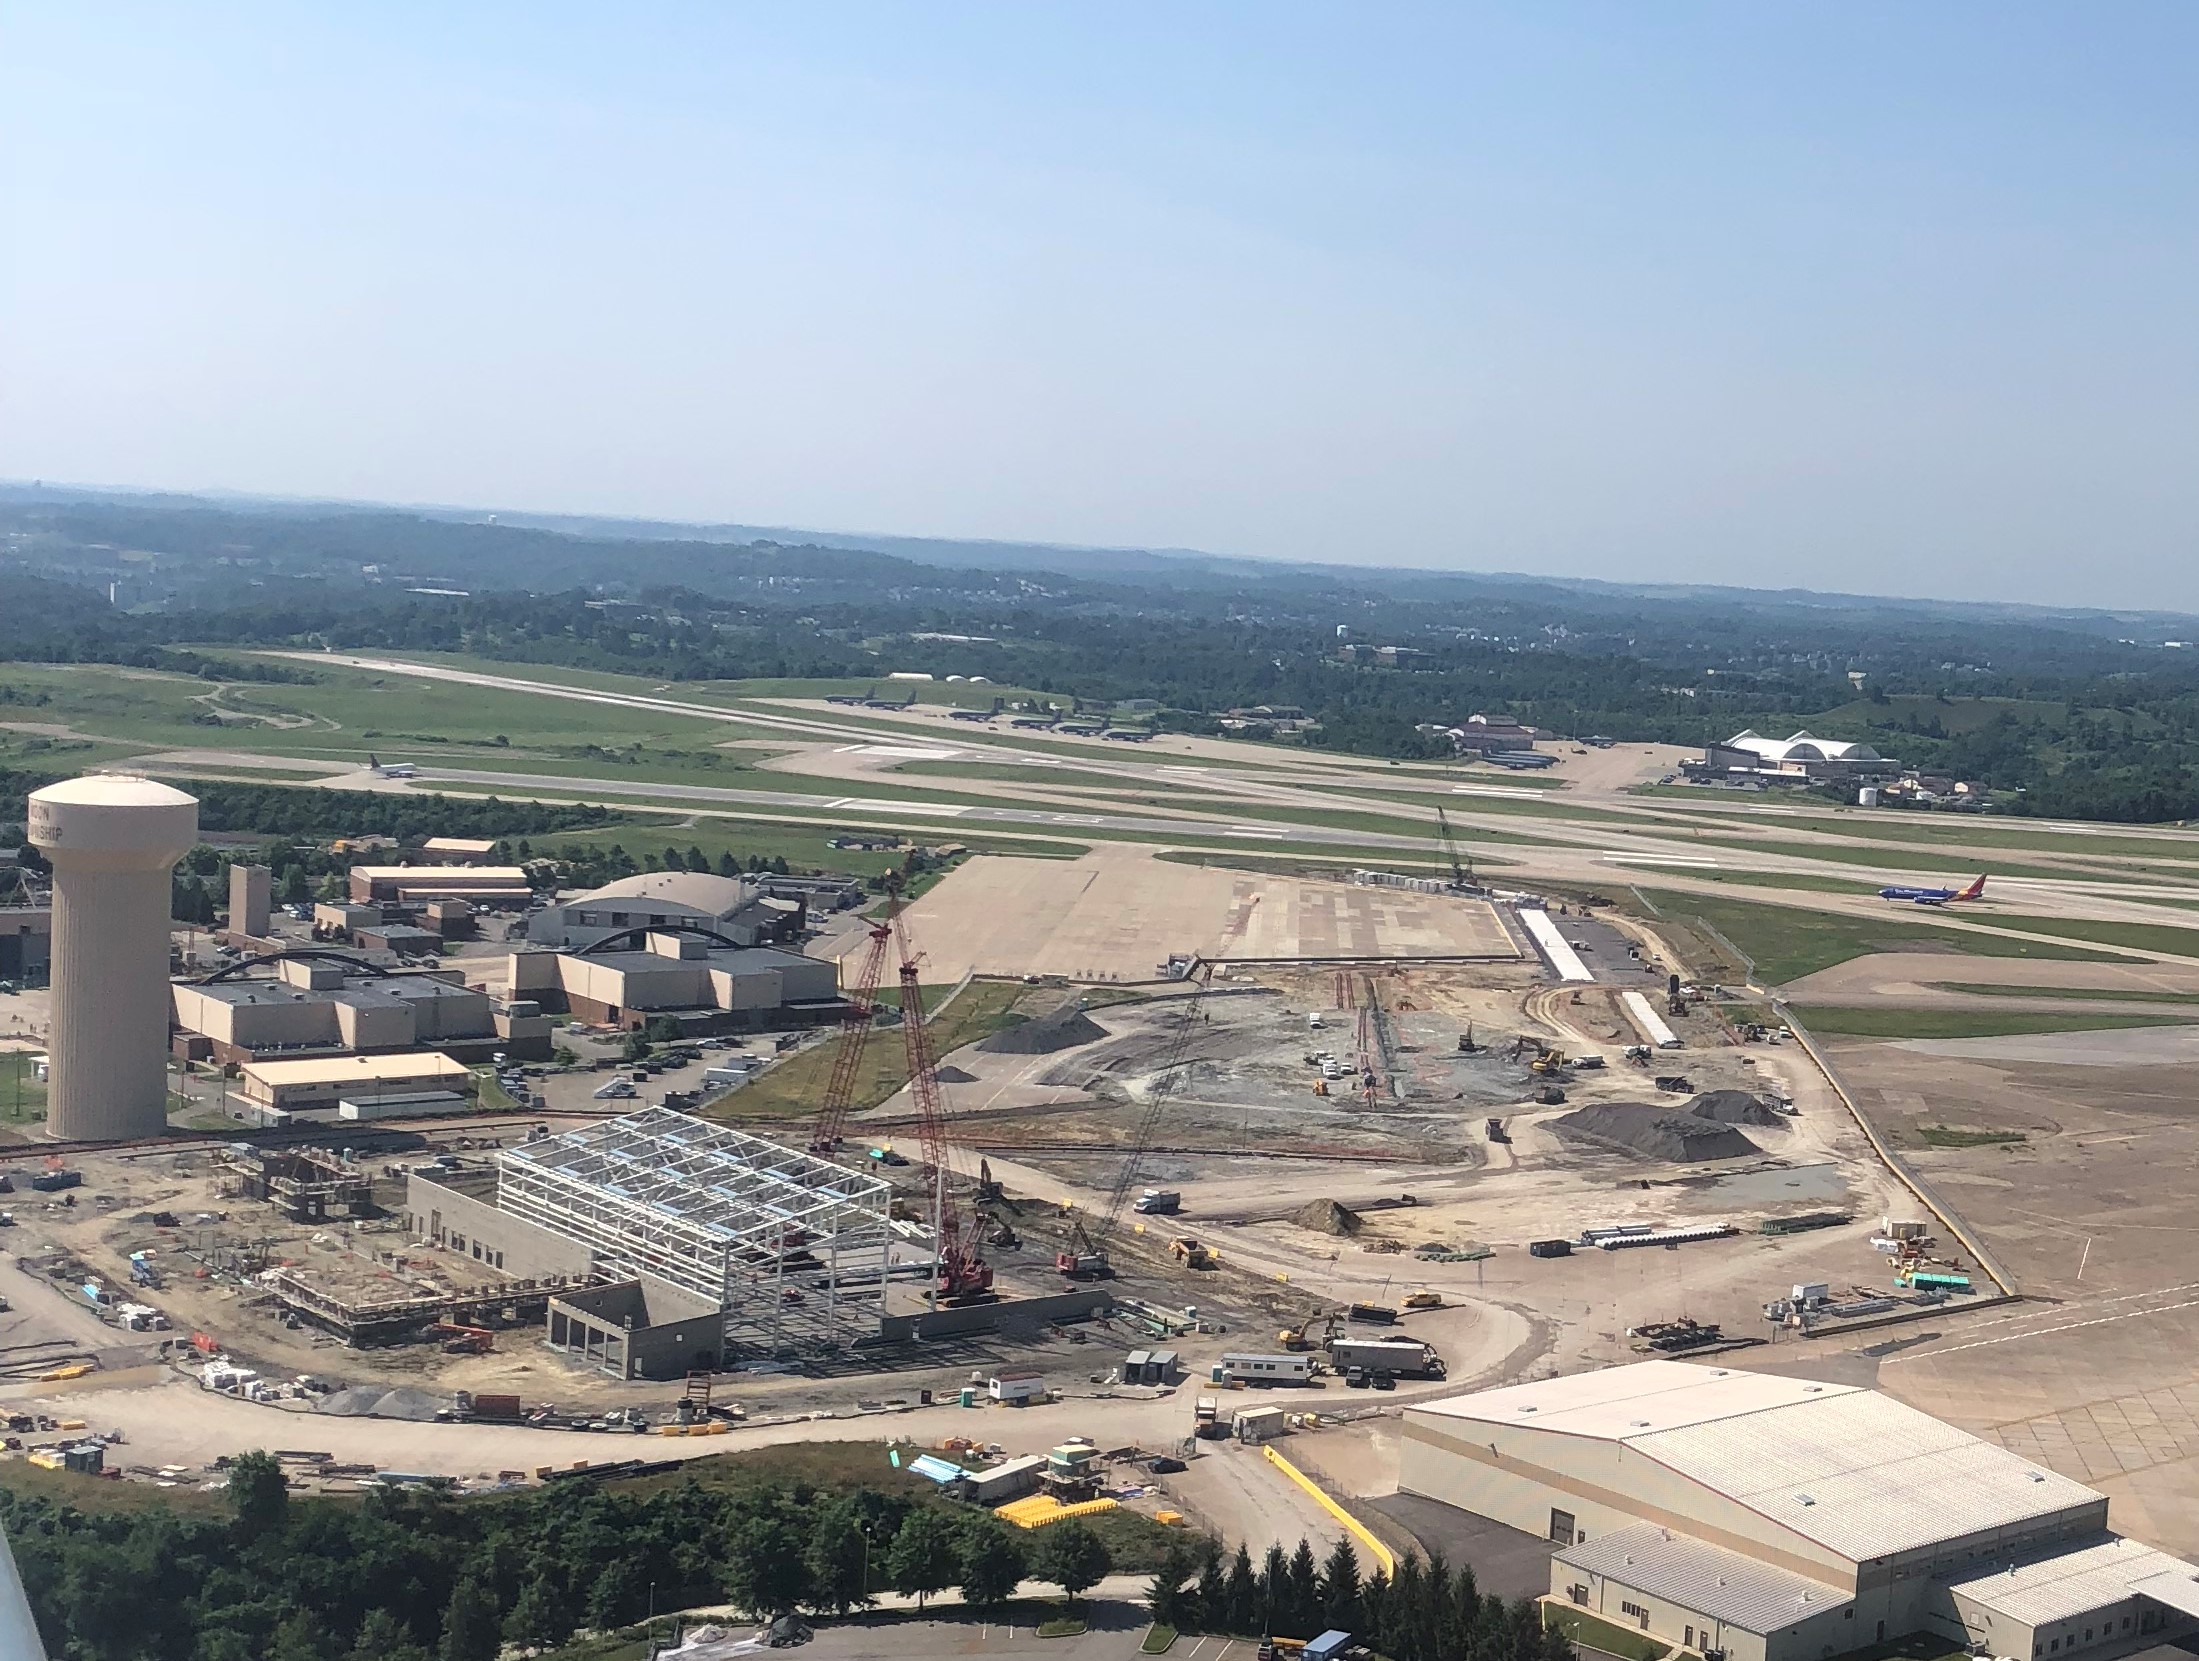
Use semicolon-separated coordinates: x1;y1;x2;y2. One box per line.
0;0;2199;609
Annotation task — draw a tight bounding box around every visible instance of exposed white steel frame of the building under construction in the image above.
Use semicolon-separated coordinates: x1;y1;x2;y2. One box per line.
497;1107;893;1349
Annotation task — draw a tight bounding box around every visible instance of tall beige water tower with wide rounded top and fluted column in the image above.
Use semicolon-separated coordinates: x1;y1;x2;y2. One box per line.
29;774;198;1142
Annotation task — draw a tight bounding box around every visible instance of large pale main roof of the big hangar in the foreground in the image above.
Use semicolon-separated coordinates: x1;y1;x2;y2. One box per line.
1407;1362;2100;1562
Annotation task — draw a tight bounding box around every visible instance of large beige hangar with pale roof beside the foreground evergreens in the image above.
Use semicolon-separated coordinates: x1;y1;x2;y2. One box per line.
1399;1362;2199;1661
